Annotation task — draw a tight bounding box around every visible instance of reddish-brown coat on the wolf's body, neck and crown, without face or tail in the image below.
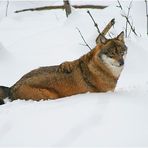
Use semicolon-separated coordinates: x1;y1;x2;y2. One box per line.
0;32;127;101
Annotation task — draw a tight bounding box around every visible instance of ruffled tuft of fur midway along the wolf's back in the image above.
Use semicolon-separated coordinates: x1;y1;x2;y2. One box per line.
57;62;73;73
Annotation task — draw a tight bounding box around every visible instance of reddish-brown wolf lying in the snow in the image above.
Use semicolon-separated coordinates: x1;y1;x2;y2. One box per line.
0;32;127;104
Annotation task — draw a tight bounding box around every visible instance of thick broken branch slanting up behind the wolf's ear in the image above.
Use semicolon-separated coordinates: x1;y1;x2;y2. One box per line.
96;19;115;44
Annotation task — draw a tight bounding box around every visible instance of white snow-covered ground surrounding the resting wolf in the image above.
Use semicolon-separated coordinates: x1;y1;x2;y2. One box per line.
0;1;148;147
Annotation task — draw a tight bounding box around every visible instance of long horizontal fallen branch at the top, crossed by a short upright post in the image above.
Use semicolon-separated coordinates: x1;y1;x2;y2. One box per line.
15;5;107;13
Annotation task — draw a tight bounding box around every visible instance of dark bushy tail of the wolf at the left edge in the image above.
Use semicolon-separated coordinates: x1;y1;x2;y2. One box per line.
0;86;10;105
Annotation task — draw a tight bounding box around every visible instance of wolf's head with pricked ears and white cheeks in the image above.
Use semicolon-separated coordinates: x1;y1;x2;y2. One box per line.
98;32;127;77
